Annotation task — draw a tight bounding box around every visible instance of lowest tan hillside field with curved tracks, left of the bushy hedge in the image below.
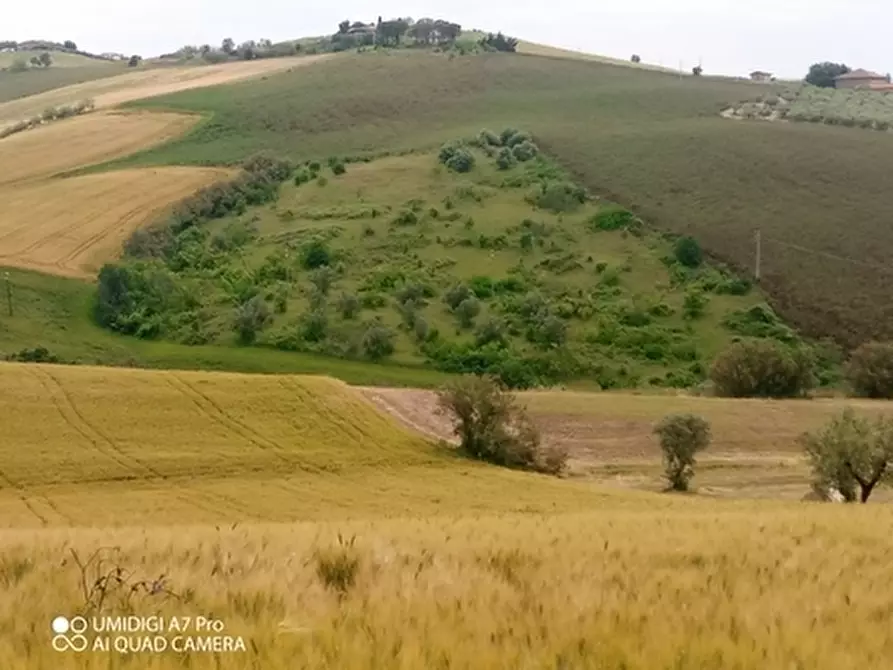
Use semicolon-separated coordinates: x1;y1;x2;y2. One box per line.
0;167;229;277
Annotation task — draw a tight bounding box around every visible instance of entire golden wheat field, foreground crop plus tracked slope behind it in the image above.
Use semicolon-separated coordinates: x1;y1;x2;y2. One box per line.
0;364;893;670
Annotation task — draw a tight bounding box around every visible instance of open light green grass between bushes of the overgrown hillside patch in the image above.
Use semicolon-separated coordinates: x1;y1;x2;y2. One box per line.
171;147;760;386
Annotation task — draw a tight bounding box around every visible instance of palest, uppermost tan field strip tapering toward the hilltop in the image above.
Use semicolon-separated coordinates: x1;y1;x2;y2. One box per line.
0;56;325;125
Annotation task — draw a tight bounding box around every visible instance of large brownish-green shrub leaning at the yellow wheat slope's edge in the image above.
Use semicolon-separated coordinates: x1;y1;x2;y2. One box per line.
438;376;567;474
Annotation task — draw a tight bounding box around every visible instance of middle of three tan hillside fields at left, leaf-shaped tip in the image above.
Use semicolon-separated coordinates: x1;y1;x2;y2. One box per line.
0;112;199;185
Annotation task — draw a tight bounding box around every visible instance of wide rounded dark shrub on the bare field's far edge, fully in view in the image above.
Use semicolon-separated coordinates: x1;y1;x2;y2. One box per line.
710;340;815;398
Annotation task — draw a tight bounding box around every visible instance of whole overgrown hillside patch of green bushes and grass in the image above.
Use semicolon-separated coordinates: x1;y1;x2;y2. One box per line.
96;137;840;396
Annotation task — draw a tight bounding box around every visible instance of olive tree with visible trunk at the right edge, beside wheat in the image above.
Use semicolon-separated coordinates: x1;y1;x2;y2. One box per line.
800;408;893;503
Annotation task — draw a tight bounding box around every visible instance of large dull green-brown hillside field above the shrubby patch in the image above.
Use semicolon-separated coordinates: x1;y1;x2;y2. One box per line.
131;53;893;350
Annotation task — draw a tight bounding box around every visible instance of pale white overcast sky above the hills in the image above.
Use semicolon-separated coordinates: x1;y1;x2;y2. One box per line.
0;0;893;77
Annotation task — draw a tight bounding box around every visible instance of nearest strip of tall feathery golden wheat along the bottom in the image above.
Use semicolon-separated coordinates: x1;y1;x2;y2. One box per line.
0;506;893;670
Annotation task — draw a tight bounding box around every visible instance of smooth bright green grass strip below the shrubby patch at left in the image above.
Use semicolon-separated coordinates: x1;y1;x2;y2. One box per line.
0;268;444;386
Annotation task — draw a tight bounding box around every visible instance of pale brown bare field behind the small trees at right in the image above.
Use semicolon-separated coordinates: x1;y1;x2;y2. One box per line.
363;388;893;499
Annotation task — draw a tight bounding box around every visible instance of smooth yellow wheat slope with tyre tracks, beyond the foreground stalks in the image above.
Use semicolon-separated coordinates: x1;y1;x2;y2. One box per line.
0;363;601;527
